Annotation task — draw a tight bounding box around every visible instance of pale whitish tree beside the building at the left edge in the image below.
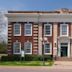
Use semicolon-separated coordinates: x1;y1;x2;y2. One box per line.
0;11;8;42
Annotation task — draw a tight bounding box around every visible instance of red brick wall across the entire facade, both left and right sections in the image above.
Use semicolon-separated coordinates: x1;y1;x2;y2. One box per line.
8;22;71;54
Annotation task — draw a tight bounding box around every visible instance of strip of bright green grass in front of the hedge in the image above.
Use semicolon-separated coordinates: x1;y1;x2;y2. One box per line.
0;61;53;66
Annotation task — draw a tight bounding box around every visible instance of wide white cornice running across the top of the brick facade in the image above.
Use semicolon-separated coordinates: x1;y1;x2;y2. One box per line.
5;13;72;22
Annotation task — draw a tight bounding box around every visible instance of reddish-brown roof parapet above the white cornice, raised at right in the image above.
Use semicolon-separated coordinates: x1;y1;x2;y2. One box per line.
8;8;72;13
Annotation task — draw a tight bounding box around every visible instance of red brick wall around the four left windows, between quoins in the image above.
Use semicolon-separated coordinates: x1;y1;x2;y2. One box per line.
8;22;38;54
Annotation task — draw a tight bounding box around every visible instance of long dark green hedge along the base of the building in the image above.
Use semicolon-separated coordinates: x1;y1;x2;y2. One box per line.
1;55;52;61
